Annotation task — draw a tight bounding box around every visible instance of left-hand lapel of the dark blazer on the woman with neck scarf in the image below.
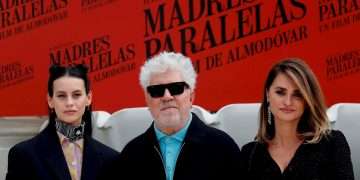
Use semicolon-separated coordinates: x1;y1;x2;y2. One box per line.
38;126;71;180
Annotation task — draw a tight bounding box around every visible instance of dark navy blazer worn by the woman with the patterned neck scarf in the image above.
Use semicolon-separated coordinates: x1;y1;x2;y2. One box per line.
6;125;119;180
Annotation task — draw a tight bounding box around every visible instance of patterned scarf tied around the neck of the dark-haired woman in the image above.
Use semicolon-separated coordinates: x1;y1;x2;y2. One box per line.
55;119;85;142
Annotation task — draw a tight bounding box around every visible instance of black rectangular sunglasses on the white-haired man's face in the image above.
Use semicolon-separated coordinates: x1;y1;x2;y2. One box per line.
146;82;189;98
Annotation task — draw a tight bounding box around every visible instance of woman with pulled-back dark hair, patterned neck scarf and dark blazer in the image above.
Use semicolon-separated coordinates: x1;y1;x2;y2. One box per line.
6;65;118;180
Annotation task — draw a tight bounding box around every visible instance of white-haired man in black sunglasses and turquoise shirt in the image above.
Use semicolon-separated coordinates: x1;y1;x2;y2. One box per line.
108;52;240;180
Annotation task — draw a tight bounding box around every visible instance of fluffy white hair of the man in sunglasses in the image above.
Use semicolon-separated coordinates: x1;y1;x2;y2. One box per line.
139;51;196;90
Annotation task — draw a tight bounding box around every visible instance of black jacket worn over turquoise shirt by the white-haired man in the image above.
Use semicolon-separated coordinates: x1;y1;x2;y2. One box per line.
102;114;240;180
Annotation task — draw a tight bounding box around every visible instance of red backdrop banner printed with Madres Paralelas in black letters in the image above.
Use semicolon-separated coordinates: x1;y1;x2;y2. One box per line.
0;0;360;116
